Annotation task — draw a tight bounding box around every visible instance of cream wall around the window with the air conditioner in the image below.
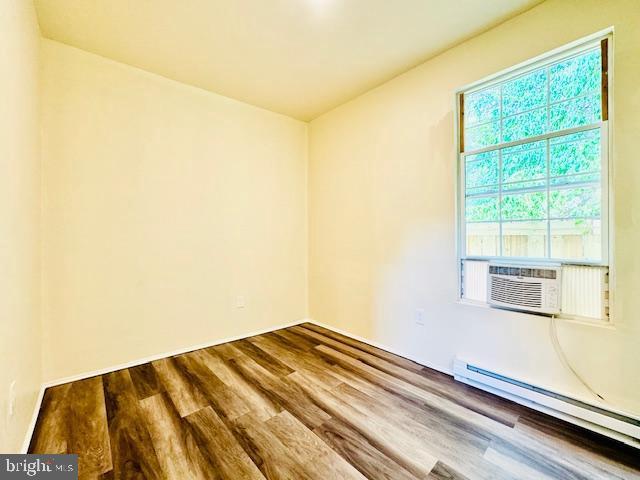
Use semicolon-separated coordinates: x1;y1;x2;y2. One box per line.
309;0;640;413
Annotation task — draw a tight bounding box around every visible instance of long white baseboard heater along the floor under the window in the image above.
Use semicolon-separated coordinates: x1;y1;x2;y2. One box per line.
453;359;640;448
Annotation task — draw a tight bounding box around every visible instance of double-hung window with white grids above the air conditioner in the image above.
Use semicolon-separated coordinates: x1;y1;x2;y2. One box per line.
459;38;609;265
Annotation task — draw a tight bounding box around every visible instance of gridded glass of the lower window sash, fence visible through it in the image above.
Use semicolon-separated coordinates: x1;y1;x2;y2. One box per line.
465;128;602;261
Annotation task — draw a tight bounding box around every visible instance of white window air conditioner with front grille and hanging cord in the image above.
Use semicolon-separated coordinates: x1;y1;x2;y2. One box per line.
487;263;561;314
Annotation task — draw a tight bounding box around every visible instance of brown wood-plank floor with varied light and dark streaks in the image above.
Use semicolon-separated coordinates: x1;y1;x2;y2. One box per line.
30;324;640;480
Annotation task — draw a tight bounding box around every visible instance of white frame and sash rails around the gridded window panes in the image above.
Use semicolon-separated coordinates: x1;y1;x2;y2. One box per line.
455;28;613;270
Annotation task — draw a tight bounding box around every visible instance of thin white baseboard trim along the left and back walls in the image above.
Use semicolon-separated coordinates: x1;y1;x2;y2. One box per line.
20;318;311;453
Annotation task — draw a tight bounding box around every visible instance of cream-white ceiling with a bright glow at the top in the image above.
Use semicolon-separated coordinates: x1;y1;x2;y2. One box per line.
35;0;542;120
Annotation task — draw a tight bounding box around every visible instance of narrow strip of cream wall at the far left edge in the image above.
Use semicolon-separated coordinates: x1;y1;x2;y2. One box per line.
0;0;42;452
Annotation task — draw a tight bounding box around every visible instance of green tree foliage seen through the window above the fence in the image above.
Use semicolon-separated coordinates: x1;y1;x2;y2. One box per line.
465;49;601;239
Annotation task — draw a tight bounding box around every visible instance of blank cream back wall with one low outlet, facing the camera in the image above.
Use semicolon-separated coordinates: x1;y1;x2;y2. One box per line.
42;40;307;379
